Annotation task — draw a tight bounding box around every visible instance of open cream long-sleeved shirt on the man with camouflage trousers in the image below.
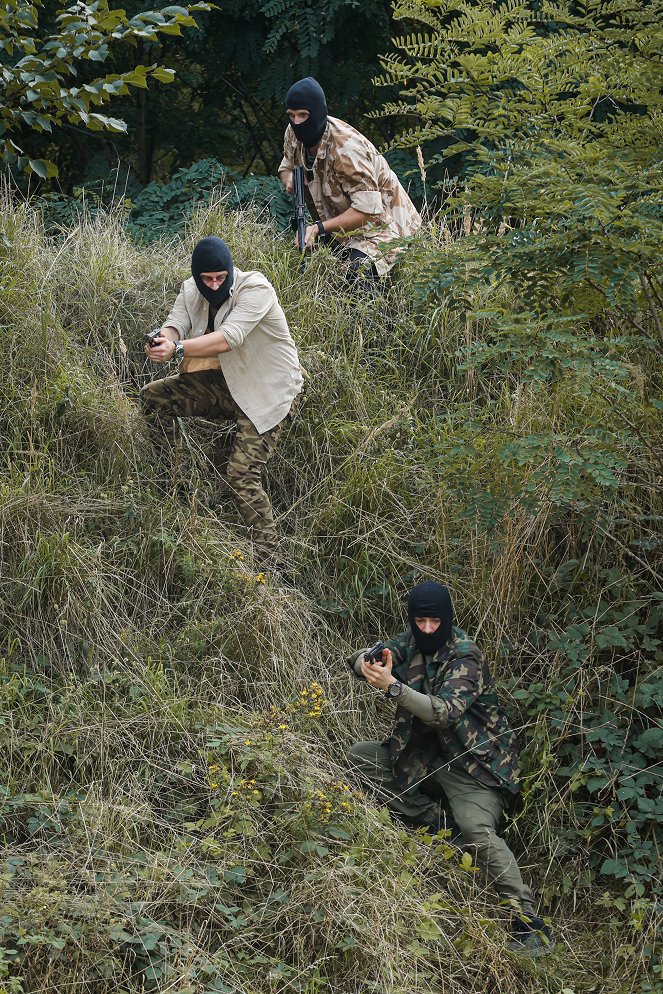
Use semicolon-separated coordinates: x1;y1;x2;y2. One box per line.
164;267;303;435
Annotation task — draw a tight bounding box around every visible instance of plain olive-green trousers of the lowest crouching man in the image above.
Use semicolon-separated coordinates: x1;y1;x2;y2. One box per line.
348;742;534;915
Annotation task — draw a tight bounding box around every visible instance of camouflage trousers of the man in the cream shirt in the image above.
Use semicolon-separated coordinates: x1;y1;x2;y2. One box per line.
140;369;290;556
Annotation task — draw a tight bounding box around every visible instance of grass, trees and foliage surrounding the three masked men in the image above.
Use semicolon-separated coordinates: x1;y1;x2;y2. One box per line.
0;0;663;994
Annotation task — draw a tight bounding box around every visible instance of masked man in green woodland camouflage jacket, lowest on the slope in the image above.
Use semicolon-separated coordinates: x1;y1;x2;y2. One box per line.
348;581;553;955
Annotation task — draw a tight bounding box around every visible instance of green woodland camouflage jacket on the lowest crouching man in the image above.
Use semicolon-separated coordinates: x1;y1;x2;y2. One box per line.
350;628;520;794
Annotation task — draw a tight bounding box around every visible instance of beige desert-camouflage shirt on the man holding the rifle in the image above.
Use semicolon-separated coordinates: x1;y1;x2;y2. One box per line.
279;117;421;276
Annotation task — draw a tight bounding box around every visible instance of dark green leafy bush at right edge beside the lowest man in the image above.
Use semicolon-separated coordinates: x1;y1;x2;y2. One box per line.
513;580;663;898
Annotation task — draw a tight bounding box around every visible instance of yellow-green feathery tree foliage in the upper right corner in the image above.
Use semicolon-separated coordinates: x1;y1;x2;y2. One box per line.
379;0;663;334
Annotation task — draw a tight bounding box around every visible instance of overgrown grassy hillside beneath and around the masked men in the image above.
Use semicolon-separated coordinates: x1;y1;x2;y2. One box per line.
0;188;663;994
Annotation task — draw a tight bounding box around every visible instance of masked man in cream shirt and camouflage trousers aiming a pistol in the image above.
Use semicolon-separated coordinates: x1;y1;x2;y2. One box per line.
141;237;303;565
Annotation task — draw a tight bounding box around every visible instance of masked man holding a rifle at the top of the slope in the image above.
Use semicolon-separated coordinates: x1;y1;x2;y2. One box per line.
279;76;421;278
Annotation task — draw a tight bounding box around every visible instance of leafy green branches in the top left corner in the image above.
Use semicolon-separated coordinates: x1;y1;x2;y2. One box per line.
0;0;210;179
